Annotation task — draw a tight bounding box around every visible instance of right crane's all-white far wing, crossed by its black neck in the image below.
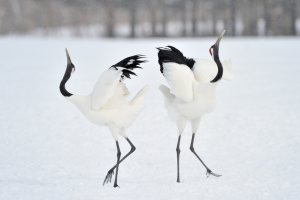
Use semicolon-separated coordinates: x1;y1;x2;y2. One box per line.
193;59;234;83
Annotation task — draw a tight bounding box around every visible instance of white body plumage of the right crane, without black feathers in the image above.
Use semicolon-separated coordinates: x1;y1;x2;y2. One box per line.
159;59;234;135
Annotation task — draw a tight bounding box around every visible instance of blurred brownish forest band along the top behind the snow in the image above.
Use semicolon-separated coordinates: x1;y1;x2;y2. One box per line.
0;0;300;37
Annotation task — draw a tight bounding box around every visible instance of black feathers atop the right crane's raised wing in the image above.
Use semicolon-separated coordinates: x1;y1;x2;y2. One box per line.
157;46;195;74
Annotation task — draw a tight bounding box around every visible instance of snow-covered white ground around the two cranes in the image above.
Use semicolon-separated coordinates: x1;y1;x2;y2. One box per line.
0;36;300;200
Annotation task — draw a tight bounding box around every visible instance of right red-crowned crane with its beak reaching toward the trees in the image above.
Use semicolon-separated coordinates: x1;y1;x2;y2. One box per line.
158;30;234;182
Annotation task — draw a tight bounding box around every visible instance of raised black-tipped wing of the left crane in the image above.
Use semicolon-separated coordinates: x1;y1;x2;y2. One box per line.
92;55;146;110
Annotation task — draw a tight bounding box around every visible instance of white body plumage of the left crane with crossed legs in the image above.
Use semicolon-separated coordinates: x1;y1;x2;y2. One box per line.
65;68;149;140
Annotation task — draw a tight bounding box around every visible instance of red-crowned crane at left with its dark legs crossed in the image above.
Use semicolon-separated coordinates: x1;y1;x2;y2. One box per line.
59;49;149;187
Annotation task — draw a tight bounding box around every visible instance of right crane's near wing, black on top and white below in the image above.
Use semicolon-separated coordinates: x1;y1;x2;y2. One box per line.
158;46;195;102
